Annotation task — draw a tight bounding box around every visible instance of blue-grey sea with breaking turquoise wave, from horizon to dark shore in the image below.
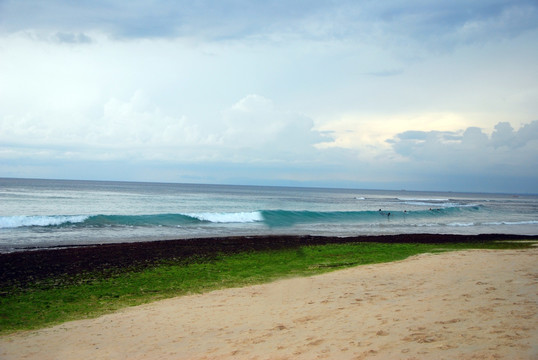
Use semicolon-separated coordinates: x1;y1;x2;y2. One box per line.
0;178;538;252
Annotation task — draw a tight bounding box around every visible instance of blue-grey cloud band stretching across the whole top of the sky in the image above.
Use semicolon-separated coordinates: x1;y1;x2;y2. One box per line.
0;0;538;43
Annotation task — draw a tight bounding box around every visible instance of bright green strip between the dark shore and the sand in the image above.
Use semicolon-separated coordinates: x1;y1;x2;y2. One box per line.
0;242;530;334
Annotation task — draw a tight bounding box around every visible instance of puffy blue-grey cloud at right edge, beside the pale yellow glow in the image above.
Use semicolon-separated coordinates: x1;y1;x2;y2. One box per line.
388;121;538;177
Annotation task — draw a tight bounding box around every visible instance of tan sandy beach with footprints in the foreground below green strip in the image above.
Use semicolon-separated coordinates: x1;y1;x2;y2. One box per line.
0;249;538;360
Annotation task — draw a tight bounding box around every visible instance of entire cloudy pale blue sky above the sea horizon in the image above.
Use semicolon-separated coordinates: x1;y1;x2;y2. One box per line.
0;0;538;193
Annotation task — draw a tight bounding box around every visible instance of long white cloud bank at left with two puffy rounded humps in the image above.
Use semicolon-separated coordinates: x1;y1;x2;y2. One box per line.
0;91;321;162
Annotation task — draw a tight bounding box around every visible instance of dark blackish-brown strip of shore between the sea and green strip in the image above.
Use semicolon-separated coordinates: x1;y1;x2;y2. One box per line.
0;234;538;290
